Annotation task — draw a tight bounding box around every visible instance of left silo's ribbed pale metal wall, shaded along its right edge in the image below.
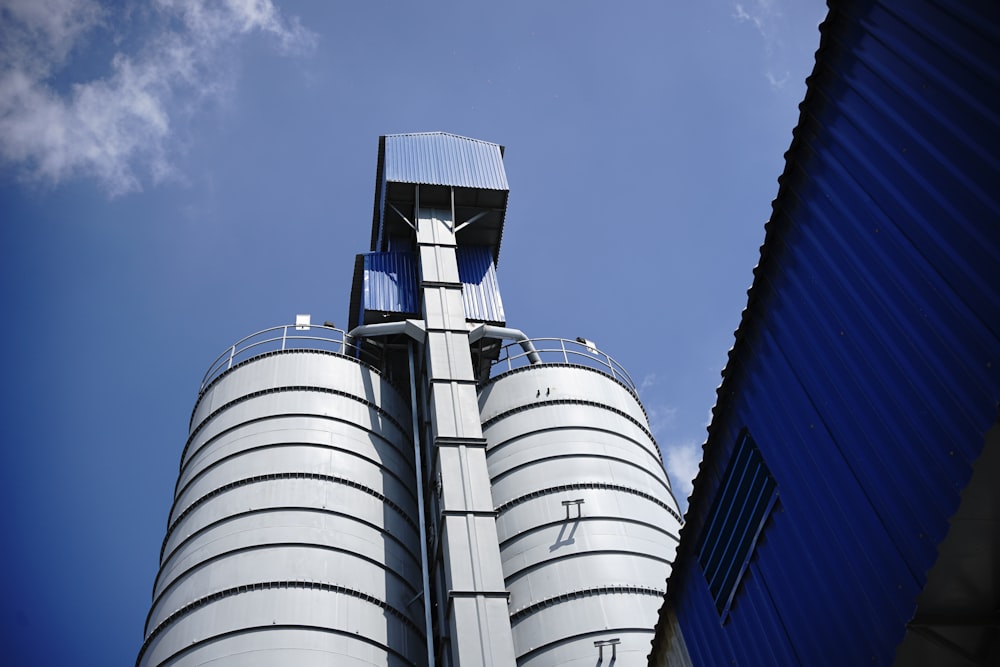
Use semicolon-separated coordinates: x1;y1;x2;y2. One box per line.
137;350;425;667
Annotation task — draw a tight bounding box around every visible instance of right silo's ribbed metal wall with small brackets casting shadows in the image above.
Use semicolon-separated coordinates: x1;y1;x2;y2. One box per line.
480;364;680;667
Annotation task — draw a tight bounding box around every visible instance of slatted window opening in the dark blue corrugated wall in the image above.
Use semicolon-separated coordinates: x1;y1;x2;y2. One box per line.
698;431;777;617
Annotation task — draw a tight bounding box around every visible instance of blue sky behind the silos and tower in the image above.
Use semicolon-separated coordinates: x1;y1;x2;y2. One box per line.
0;0;825;666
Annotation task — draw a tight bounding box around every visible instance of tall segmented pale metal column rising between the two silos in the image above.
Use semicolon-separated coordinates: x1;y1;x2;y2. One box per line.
415;189;514;667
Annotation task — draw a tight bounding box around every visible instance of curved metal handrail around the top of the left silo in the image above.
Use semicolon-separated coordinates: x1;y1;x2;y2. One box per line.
198;324;360;394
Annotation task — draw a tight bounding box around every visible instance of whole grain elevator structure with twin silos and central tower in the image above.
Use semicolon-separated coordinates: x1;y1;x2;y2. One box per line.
137;133;680;667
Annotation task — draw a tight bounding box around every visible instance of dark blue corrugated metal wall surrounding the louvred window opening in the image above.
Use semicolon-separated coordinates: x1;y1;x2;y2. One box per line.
654;1;1000;665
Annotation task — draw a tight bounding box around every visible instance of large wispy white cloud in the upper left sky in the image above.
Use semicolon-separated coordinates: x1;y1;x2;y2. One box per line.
0;0;315;196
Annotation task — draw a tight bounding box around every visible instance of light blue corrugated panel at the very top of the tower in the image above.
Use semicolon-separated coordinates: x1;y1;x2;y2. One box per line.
384;132;509;190
